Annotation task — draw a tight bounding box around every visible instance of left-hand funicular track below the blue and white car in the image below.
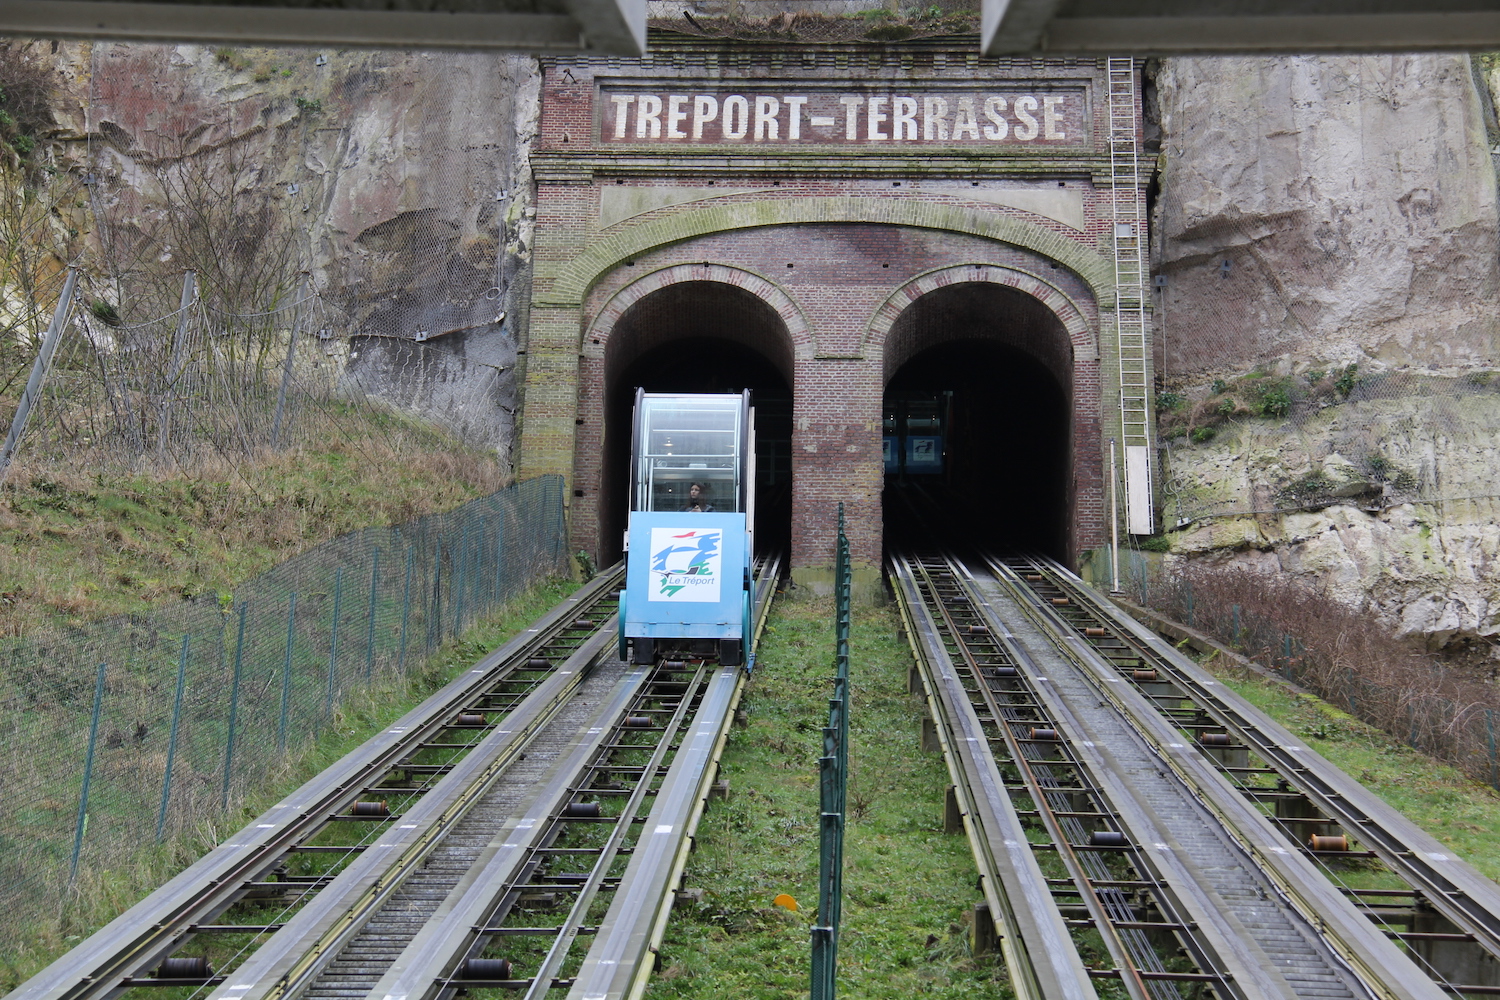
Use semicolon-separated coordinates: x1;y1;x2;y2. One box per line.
11;559;779;1000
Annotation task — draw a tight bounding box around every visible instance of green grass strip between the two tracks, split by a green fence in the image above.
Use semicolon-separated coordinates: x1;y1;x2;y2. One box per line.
647;600;1013;1000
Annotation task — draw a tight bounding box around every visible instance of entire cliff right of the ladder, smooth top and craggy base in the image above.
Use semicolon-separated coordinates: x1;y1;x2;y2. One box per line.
1148;55;1500;648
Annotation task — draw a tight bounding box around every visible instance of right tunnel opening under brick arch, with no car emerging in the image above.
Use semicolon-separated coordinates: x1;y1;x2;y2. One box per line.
884;282;1074;561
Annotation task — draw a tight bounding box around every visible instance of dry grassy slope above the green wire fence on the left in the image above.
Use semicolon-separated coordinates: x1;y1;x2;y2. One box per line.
0;412;506;636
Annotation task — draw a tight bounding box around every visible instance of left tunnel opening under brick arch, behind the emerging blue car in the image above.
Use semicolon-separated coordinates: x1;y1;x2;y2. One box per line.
599;282;792;565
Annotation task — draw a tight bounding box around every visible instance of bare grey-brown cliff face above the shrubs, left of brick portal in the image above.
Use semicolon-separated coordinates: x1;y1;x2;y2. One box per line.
76;43;540;456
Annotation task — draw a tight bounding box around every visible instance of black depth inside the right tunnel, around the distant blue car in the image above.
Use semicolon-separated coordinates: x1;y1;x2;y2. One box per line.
884;339;1071;559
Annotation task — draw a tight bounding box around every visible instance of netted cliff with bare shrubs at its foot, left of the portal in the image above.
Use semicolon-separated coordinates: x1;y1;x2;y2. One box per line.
0;45;536;469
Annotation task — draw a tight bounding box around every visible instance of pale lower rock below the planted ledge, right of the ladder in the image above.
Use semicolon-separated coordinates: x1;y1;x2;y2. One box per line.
1166;379;1500;648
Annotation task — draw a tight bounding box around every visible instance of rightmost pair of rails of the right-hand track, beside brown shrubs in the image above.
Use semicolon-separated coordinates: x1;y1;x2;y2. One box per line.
990;558;1500;997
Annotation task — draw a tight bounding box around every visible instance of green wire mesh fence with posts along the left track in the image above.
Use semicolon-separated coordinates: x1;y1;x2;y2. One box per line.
0;477;563;940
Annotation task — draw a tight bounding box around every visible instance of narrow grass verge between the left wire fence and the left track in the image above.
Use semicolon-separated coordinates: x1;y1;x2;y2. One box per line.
0;580;576;1000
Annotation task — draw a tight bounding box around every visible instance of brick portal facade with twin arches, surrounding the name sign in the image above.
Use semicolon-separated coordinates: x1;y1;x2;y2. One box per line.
522;39;1119;581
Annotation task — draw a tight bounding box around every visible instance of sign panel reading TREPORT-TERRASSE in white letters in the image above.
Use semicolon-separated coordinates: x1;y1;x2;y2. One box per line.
599;87;1089;147
